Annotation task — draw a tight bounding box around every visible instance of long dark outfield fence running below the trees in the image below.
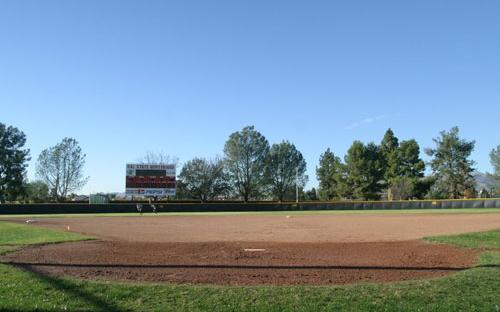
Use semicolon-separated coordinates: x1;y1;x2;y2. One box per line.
0;198;500;215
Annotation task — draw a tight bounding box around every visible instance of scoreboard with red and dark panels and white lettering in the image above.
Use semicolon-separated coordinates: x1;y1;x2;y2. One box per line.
125;164;175;197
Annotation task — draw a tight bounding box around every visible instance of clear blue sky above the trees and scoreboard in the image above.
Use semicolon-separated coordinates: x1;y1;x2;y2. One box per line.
0;0;500;192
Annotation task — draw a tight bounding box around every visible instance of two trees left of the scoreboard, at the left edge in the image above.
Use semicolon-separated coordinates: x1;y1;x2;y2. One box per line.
0;123;88;203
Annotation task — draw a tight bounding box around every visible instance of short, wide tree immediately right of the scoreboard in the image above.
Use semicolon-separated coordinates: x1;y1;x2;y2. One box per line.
179;158;228;201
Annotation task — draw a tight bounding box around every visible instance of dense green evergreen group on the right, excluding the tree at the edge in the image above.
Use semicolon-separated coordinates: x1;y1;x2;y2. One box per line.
316;127;476;200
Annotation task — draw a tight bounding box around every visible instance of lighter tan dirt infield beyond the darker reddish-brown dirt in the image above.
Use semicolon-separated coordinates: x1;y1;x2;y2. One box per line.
10;213;500;243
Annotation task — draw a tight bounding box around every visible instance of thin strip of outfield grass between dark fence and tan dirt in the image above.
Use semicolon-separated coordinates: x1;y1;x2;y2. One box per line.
0;208;500;219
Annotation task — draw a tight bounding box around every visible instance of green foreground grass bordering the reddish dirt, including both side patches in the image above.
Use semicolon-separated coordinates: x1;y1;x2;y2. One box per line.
0;222;500;312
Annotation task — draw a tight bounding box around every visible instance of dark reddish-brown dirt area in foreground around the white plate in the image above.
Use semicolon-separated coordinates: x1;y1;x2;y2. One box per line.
2;240;477;285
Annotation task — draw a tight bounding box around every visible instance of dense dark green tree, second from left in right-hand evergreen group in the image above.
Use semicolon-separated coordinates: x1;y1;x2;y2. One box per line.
345;141;384;200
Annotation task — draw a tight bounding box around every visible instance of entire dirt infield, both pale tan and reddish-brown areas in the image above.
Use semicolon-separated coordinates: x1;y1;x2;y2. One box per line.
2;214;500;285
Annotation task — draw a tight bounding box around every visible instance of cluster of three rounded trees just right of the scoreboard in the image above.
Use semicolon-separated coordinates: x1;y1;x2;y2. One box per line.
177;126;308;201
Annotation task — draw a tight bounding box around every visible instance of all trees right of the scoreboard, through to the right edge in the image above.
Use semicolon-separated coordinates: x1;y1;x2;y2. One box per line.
178;127;500;201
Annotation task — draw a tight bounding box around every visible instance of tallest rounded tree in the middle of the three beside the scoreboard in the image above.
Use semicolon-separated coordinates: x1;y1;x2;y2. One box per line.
224;126;269;201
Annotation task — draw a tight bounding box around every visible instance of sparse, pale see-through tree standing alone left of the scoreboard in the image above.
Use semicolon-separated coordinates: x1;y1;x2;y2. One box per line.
36;138;88;201
